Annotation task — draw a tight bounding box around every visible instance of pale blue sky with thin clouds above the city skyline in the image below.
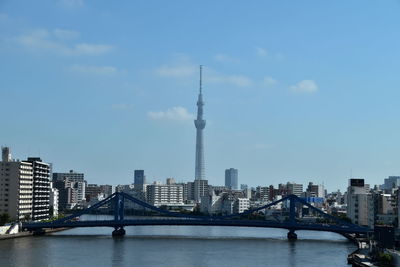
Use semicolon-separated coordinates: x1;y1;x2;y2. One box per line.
0;0;400;191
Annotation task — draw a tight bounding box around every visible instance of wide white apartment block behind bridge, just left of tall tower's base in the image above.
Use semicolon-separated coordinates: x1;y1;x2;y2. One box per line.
146;184;183;207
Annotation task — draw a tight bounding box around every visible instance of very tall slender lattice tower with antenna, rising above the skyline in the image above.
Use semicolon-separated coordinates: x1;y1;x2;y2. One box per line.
194;66;206;180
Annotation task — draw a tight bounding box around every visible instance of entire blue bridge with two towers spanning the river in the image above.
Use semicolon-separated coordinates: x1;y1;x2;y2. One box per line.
22;192;371;240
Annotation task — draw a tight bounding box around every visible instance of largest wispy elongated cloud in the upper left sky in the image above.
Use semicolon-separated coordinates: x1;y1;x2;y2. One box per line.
14;29;113;55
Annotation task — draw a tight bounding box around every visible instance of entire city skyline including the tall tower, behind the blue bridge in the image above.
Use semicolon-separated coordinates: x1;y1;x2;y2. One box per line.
0;69;400;245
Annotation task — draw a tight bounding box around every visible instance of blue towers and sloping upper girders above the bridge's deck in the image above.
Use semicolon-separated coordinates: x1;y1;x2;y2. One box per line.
23;192;368;237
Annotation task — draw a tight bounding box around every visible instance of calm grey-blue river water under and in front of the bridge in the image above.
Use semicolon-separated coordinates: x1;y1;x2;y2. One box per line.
0;217;356;267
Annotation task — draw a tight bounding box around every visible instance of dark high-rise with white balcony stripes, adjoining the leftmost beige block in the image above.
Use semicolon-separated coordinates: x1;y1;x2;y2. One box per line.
26;157;50;221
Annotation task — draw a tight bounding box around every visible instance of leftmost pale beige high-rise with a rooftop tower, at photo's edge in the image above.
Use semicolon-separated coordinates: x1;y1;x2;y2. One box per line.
0;147;33;220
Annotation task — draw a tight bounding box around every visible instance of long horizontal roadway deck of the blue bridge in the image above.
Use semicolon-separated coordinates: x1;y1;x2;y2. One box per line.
22;218;368;234
